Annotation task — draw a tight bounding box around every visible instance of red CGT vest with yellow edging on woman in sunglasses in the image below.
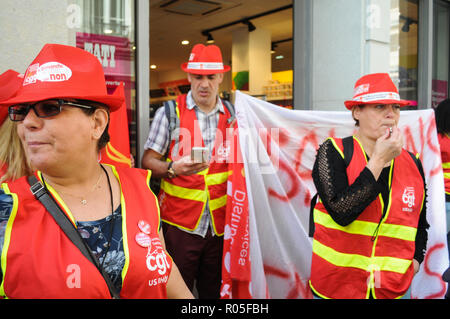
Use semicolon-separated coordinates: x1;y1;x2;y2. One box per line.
0;167;172;299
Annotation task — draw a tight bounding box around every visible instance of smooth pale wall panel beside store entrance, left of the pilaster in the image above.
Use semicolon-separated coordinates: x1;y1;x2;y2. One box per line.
312;0;364;110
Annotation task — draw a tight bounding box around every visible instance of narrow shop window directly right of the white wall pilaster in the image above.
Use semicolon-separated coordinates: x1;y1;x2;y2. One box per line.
389;0;419;109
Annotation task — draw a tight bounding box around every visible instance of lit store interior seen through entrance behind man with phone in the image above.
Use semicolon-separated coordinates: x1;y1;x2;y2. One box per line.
150;0;293;112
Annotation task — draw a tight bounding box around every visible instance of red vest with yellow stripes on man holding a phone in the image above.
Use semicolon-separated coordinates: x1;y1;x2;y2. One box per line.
159;95;232;236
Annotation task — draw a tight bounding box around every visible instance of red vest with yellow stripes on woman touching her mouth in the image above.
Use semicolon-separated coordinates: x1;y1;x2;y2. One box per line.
310;138;424;299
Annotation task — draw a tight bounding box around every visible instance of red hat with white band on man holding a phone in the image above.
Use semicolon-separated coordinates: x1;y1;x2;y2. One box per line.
181;44;230;74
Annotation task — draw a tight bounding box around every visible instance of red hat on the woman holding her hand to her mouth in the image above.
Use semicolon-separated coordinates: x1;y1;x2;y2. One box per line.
344;73;410;110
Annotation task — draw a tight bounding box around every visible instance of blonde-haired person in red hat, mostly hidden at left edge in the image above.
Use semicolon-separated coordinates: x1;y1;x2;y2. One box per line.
0;70;31;183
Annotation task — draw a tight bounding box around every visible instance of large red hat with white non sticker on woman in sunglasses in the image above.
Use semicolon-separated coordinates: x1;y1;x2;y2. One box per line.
0;44;124;112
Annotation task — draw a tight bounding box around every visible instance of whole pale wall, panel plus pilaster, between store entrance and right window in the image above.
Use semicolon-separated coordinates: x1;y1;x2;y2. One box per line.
294;0;390;111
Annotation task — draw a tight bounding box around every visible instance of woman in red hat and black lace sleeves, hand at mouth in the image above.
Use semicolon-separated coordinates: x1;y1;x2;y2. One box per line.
310;73;429;299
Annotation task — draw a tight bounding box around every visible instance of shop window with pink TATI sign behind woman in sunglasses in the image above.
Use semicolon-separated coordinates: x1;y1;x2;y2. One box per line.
72;0;137;158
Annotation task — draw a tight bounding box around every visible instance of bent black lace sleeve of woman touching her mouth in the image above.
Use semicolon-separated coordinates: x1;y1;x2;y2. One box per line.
312;140;381;226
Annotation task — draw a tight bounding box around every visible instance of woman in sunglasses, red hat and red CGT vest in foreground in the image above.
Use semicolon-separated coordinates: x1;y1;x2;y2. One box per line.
0;44;192;299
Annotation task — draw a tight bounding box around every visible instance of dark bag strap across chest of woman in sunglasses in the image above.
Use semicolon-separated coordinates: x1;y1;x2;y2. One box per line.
28;175;119;299
